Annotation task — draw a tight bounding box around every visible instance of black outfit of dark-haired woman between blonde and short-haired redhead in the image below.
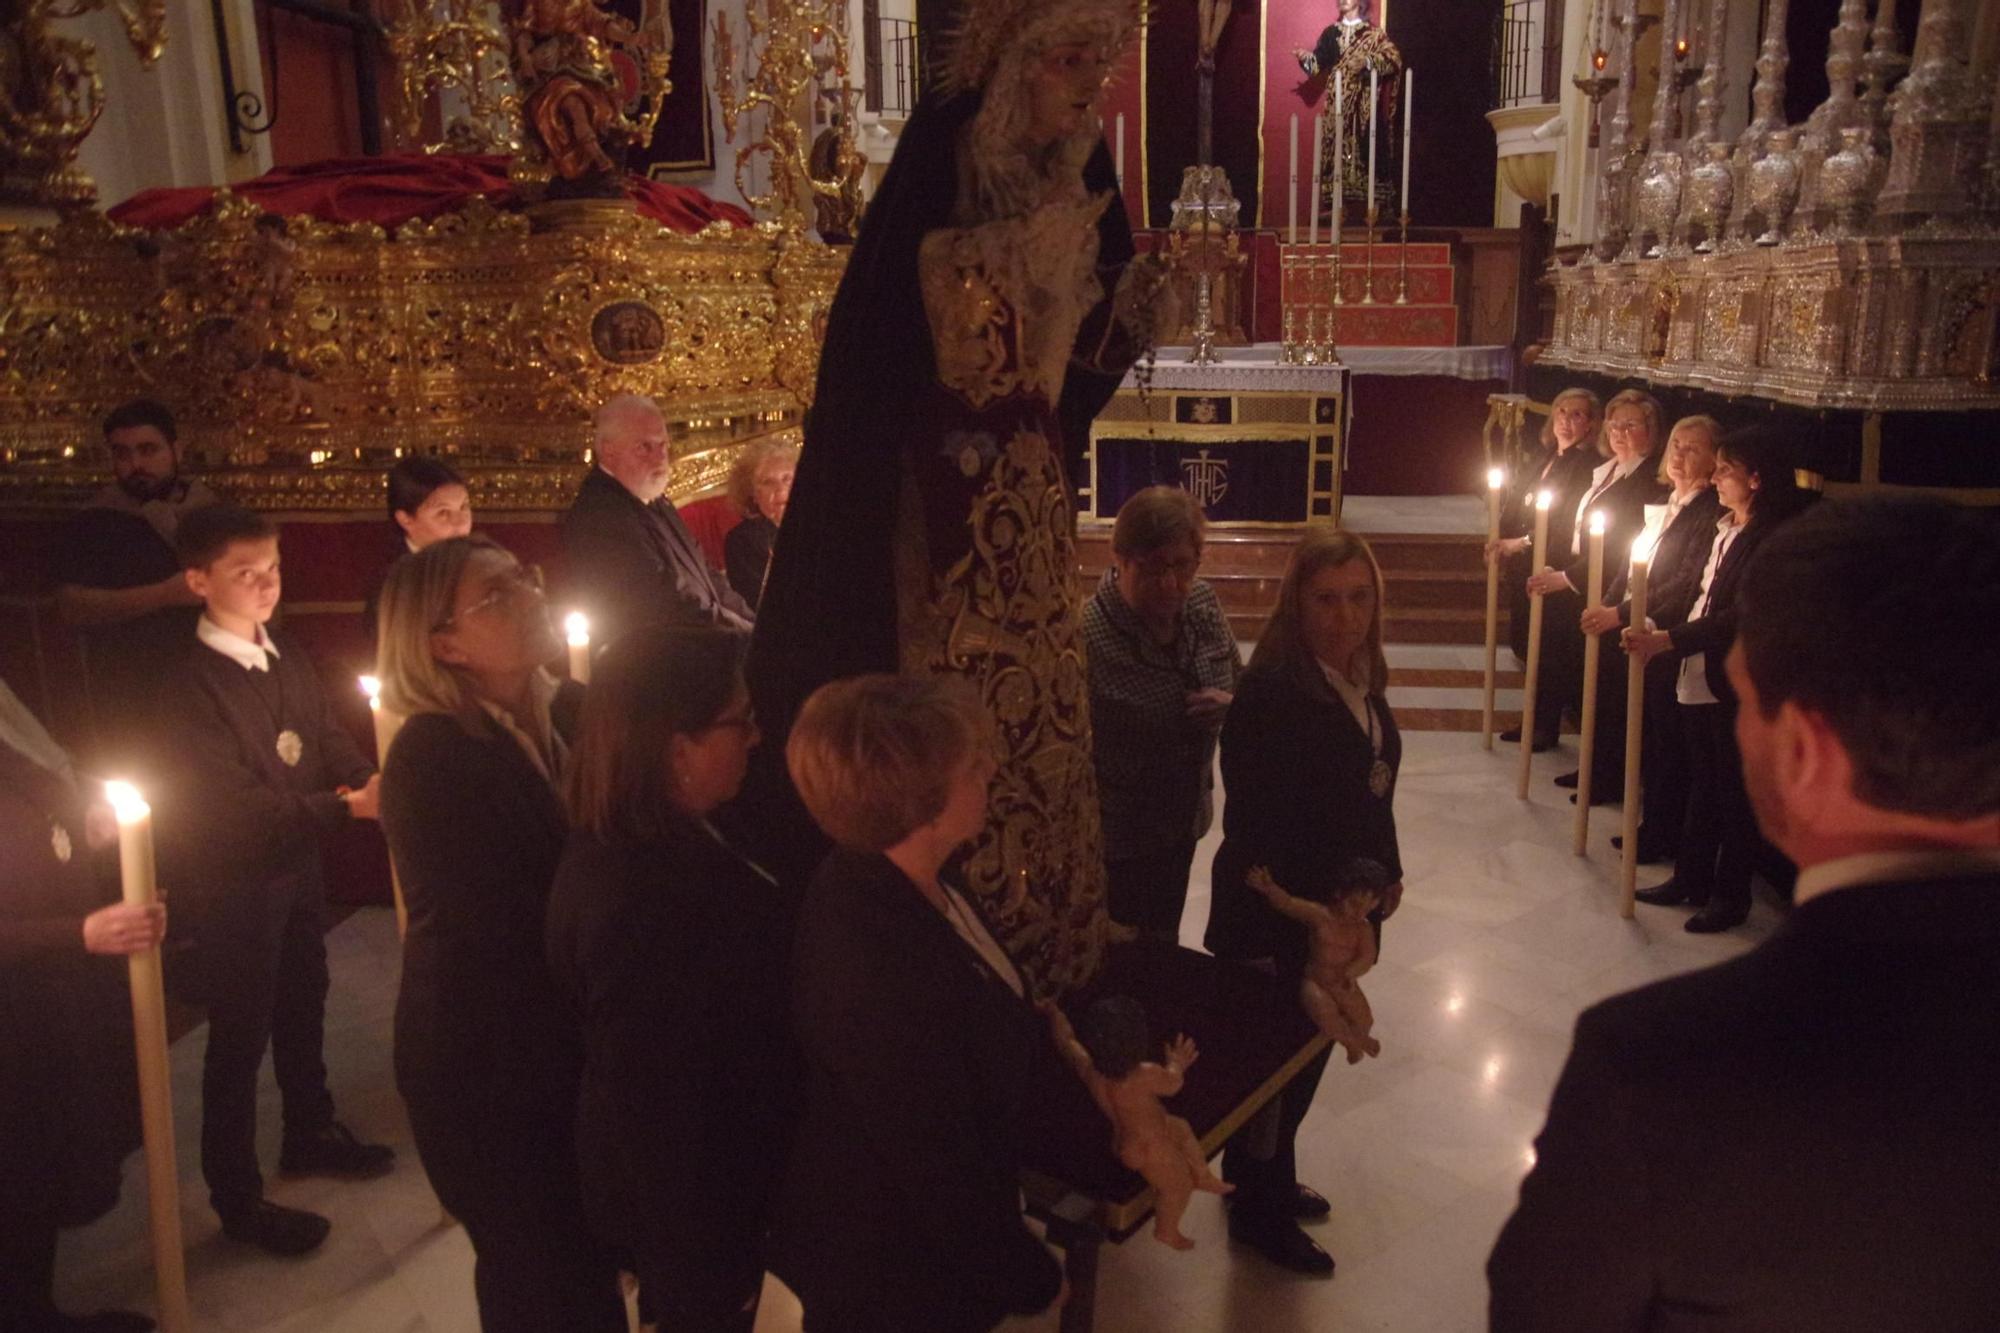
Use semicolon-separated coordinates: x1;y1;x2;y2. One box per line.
548;821;800;1327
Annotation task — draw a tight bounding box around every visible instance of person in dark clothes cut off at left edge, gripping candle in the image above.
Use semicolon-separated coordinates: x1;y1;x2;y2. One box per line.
0;683;166;1333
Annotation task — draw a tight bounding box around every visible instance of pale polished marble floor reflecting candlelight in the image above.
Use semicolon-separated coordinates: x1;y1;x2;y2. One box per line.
58;733;1776;1333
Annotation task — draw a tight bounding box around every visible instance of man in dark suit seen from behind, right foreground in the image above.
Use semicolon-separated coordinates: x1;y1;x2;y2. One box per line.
1486;500;2000;1333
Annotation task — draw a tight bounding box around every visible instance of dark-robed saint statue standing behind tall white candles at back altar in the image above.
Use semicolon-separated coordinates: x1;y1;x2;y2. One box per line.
1292;0;1402;216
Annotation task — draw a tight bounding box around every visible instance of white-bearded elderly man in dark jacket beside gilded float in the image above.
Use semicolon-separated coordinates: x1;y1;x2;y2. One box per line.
562;394;756;644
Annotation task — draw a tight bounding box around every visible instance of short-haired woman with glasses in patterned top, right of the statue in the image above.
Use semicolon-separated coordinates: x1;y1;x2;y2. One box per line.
1084;486;1242;943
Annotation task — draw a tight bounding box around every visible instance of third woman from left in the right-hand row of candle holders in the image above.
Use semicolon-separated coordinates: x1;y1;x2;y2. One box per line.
1582;416;1722;865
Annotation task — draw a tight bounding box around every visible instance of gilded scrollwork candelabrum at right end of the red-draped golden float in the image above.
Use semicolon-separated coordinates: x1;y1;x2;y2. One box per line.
714;0;862;234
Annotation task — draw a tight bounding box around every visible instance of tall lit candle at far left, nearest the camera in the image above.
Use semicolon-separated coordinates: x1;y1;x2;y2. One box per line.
104;783;194;1333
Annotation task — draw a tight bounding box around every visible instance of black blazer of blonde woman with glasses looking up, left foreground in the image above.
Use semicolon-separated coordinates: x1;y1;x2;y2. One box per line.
382;685;582;1119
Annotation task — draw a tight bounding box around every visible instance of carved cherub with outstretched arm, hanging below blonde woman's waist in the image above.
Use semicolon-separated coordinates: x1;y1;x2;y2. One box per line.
1042;997;1234;1249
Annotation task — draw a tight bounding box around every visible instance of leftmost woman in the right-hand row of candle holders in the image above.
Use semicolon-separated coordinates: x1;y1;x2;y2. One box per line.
1486;388;1604;751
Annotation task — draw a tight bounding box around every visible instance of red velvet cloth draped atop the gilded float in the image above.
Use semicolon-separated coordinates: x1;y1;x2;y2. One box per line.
110;152;752;232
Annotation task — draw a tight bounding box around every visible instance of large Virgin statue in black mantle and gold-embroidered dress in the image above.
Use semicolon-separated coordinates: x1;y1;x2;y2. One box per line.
750;0;1168;995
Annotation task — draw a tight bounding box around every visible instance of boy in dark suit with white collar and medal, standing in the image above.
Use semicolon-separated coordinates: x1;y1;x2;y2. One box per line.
156;504;394;1255
